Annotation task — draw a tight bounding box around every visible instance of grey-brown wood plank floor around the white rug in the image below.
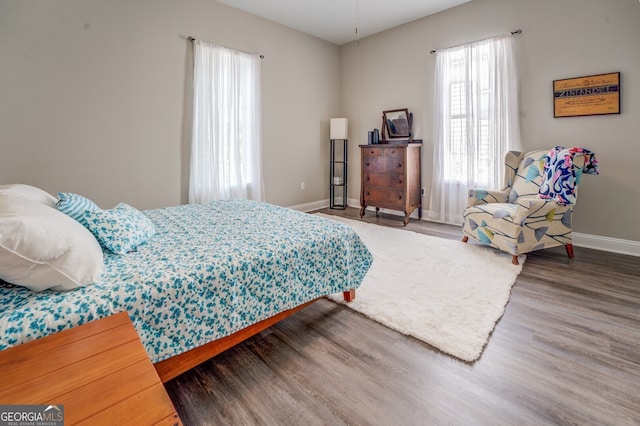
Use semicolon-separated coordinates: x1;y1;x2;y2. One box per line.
166;208;640;425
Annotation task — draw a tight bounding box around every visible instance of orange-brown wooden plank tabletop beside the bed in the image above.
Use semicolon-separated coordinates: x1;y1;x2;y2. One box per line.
0;312;181;425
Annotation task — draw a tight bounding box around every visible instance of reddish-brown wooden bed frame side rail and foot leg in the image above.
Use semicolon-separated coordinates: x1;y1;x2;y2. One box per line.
154;289;356;383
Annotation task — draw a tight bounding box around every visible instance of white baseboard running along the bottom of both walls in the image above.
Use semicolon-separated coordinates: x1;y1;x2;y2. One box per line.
300;198;640;257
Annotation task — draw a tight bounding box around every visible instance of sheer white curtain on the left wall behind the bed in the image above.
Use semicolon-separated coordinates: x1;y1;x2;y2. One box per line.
189;40;264;203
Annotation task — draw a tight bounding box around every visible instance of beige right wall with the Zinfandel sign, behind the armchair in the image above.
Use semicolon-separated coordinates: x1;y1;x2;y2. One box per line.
341;0;640;241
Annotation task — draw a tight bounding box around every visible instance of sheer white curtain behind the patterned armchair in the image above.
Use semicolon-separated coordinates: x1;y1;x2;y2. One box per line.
429;35;520;224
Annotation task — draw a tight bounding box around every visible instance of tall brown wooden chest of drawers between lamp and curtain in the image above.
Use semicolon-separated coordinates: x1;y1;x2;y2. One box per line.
360;140;422;225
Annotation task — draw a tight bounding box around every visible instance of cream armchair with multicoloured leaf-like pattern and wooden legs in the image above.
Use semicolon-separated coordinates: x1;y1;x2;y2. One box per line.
462;148;598;265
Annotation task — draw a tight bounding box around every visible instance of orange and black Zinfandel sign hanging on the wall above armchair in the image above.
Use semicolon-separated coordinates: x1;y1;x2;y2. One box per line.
553;72;620;117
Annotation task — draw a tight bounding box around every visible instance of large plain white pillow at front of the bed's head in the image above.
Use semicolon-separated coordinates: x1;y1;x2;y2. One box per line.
0;193;104;291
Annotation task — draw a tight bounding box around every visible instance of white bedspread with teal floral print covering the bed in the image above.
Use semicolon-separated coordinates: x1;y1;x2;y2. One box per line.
0;200;372;362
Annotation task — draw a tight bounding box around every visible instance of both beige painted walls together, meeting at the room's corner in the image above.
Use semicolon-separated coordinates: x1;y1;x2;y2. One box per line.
0;0;640;241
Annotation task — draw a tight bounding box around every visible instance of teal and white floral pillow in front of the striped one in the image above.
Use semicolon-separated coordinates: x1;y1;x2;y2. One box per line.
84;203;155;254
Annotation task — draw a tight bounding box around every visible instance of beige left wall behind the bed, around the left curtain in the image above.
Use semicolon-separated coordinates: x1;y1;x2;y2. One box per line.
0;0;340;208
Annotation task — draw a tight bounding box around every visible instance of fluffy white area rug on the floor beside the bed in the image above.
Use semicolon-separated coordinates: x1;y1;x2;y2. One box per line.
319;214;525;361
